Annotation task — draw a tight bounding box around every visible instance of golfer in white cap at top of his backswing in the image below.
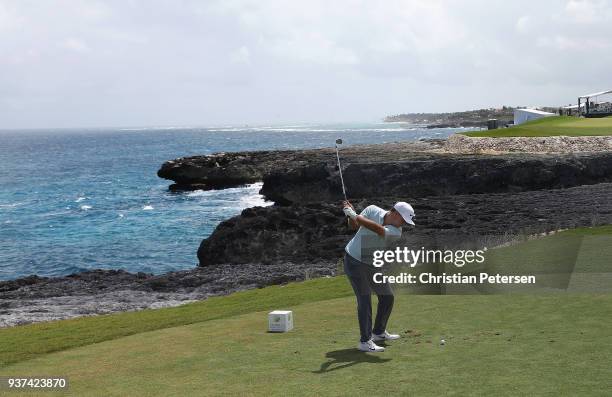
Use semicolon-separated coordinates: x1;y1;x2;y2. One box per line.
342;201;414;352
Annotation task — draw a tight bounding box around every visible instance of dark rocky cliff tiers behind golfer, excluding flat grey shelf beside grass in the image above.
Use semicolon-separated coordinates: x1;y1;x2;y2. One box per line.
160;139;612;266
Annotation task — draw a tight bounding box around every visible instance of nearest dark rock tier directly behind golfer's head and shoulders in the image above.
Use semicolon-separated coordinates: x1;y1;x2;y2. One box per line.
198;183;612;266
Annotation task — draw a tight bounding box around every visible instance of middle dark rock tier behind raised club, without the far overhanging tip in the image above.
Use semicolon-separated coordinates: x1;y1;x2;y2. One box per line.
261;153;612;205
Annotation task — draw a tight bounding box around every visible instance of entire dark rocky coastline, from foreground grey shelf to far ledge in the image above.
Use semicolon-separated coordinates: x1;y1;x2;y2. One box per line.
0;136;612;326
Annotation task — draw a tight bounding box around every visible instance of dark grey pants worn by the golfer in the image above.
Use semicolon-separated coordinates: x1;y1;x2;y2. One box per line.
344;253;394;342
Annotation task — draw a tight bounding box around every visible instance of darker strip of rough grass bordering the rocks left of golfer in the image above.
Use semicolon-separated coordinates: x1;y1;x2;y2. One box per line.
0;278;352;369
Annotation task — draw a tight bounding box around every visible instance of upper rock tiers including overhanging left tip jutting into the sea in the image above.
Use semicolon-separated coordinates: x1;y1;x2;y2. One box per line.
158;141;612;205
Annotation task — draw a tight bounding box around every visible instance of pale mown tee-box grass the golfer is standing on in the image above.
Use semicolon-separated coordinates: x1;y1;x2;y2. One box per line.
2;295;612;396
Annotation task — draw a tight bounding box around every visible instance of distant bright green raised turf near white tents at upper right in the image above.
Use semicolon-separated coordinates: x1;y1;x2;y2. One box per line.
463;116;612;137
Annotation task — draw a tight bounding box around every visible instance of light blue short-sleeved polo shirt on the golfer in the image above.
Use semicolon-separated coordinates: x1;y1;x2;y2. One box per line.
345;205;402;264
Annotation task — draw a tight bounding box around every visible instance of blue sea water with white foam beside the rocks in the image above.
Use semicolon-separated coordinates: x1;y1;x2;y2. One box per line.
0;123;455;280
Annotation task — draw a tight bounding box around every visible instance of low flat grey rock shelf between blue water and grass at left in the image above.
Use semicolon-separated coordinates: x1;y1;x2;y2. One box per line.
0;261;337;327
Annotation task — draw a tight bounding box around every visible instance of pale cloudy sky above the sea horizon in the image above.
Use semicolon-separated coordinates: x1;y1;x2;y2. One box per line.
0;0;612;129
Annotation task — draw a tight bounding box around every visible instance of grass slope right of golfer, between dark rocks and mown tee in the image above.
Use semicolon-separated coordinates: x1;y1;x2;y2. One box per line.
394;225;612;294
